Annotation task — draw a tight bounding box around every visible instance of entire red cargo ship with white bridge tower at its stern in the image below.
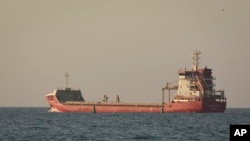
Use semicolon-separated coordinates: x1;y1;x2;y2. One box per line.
46;50;226;113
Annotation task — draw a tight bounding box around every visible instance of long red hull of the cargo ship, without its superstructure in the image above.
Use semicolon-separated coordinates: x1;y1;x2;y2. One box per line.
48;97;226;113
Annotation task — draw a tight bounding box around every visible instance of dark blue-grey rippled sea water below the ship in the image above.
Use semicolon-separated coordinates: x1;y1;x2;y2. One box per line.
0;108;250;141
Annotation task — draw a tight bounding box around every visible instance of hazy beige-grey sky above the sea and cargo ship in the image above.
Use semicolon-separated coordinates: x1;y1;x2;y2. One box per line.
0;0;250;108
